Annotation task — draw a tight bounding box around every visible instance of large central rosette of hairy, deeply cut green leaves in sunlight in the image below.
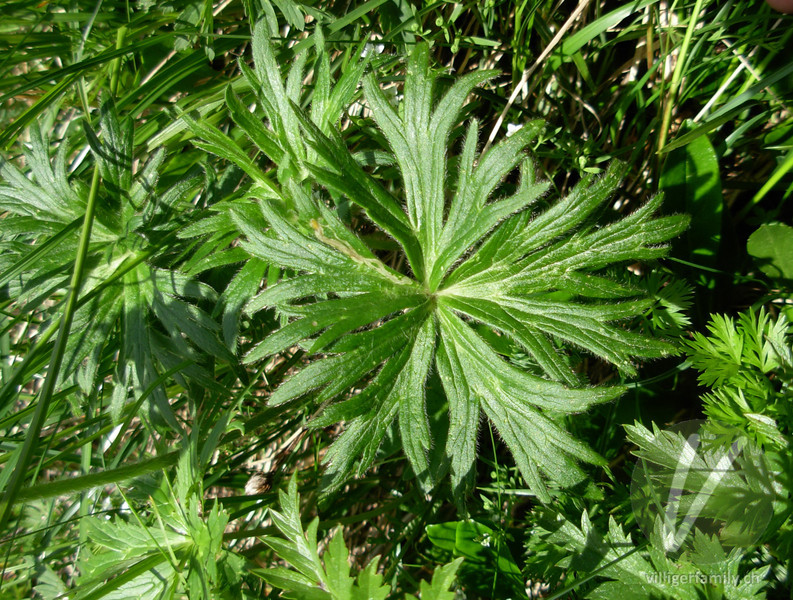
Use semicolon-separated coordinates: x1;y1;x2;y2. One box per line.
213;28;687;500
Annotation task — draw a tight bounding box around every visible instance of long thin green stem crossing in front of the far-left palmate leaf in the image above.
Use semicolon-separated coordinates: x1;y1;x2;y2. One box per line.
0;165;99;530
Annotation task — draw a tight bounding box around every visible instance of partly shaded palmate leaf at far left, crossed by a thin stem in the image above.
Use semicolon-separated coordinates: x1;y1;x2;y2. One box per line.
0;101;229;422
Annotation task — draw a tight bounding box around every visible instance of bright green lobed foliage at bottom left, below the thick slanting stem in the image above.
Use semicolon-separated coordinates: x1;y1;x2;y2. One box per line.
73;452;244;600
